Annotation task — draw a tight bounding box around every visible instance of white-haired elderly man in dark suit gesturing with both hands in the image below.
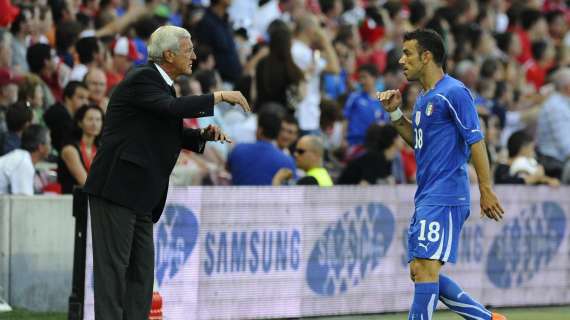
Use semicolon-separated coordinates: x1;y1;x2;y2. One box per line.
84;26;250;320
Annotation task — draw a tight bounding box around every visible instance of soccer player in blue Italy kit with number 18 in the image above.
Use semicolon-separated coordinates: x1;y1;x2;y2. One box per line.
377;30;506;320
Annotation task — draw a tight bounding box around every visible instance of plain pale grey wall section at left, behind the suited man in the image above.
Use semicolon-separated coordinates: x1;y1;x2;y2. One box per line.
0;196;75;311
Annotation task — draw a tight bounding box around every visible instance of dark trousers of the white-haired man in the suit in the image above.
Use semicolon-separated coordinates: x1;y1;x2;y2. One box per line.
89;196;154;320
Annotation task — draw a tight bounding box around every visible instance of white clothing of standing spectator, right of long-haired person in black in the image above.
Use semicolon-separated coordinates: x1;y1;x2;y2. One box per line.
291;40;327;130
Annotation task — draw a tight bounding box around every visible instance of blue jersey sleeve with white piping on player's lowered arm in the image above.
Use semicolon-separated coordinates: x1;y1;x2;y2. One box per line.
439;87;483;145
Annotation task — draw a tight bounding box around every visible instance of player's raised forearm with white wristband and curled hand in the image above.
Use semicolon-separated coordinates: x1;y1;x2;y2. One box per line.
376;90;414;147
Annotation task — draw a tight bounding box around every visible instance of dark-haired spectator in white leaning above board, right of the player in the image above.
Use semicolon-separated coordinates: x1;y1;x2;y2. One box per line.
495;131;560;186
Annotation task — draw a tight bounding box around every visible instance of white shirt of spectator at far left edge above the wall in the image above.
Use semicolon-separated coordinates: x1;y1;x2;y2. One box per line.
0;149;36;196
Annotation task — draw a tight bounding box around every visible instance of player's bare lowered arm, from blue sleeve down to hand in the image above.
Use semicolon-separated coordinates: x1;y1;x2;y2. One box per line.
471;140;504;221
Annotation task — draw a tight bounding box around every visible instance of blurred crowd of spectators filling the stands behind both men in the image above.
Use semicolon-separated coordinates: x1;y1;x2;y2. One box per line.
0;0;570;194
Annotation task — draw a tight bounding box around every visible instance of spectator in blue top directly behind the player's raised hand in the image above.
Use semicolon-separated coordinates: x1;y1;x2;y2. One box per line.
344;64;390;146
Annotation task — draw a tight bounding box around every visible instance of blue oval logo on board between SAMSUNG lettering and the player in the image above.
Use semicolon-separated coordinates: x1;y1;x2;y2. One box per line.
306;203;395;296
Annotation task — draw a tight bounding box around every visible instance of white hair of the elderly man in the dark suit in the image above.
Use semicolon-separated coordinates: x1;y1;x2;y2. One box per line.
148;26;191;64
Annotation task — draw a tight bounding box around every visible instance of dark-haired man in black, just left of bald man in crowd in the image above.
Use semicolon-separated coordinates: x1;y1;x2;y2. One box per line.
44;81;89;153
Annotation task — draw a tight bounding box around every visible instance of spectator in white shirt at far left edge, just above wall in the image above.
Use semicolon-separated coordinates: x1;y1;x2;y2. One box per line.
0;124;50;196
